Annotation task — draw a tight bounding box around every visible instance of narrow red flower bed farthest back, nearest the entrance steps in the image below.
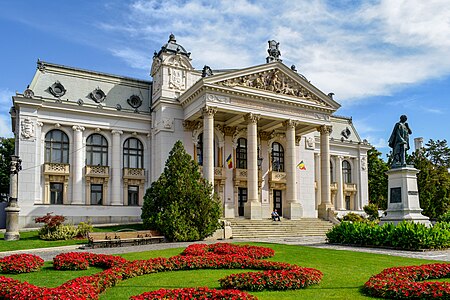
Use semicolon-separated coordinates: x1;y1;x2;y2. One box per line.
181;243;275;259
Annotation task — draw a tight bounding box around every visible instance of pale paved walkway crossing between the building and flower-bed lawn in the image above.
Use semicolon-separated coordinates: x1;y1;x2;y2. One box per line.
0;236;450;262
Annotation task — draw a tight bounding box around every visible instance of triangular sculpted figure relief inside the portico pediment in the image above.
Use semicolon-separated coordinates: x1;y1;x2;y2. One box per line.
218;69;325;105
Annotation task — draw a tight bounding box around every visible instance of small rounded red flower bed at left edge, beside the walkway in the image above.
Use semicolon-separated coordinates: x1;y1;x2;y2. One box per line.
0;254;44;274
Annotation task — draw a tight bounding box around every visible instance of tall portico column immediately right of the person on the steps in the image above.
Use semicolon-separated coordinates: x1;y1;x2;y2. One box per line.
283;120;302;220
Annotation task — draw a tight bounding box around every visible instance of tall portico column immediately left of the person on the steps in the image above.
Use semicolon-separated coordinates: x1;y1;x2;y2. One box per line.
244;113;261;220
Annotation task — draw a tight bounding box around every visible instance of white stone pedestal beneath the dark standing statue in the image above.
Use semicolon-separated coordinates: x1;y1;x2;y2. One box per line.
380;166;431;225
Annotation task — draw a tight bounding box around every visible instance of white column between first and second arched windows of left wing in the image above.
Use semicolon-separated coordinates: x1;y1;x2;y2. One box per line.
71;125;88;204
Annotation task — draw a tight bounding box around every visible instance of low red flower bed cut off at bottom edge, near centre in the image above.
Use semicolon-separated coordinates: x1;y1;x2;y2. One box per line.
130;287;257;300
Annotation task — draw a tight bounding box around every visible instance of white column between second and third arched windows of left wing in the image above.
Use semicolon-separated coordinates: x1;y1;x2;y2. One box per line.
111;130;122;205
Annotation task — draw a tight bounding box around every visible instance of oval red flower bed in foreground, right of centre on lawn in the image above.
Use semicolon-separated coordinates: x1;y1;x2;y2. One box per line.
219;267;323;291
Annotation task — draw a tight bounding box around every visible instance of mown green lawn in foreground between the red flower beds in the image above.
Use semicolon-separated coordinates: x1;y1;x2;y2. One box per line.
2;243;446;300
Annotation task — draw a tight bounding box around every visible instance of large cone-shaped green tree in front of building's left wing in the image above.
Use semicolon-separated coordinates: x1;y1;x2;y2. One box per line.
141;141;221;241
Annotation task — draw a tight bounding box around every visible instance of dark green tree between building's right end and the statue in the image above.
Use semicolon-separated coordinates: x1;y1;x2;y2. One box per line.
367;147;389;209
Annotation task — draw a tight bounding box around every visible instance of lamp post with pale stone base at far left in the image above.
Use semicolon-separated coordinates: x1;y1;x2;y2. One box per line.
5;155;22;241
